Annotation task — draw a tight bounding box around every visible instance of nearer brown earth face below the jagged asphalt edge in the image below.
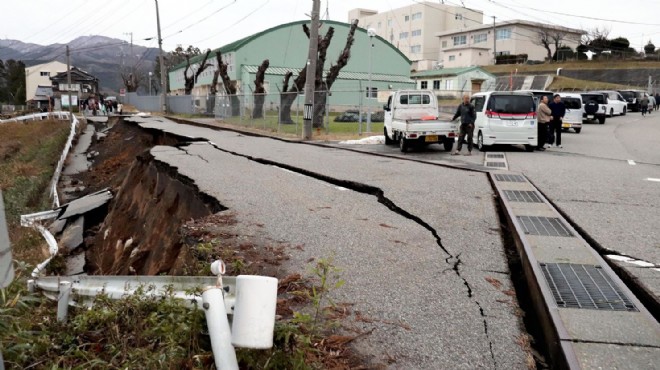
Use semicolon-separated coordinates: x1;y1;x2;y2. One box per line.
87;152;223;275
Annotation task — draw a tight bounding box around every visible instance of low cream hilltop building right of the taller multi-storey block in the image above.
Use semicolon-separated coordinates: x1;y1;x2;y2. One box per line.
436;20;586;68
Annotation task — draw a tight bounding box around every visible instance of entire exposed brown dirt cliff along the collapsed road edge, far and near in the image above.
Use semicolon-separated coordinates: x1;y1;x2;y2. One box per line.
72;118;224;275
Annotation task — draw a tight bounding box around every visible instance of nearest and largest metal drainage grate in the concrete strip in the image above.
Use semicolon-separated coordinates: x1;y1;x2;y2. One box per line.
540;263;638;311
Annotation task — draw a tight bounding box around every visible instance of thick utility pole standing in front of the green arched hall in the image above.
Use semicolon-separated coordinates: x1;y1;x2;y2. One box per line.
303;0;321;140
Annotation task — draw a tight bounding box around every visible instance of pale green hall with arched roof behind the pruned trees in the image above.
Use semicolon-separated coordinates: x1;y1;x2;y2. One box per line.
169;20;415;104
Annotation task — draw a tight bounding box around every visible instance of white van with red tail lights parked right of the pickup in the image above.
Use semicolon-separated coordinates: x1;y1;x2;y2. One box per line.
471;91;538;152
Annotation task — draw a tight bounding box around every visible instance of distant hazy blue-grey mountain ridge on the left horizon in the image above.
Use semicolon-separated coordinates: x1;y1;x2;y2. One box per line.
0;35;158;92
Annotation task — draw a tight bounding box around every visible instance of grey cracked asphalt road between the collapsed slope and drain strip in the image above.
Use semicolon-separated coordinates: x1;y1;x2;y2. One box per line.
135;120;526;369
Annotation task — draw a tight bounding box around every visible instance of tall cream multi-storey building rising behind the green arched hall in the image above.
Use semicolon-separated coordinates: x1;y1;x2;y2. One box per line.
348;1;483;71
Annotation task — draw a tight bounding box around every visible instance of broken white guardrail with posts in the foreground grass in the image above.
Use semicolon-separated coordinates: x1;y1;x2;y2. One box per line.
28;261;277;370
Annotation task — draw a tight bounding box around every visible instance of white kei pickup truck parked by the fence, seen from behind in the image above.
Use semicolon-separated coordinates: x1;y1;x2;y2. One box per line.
383;90;458;153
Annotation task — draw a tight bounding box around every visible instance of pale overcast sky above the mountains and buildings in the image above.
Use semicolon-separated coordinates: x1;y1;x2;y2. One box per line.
0;0;660;50
